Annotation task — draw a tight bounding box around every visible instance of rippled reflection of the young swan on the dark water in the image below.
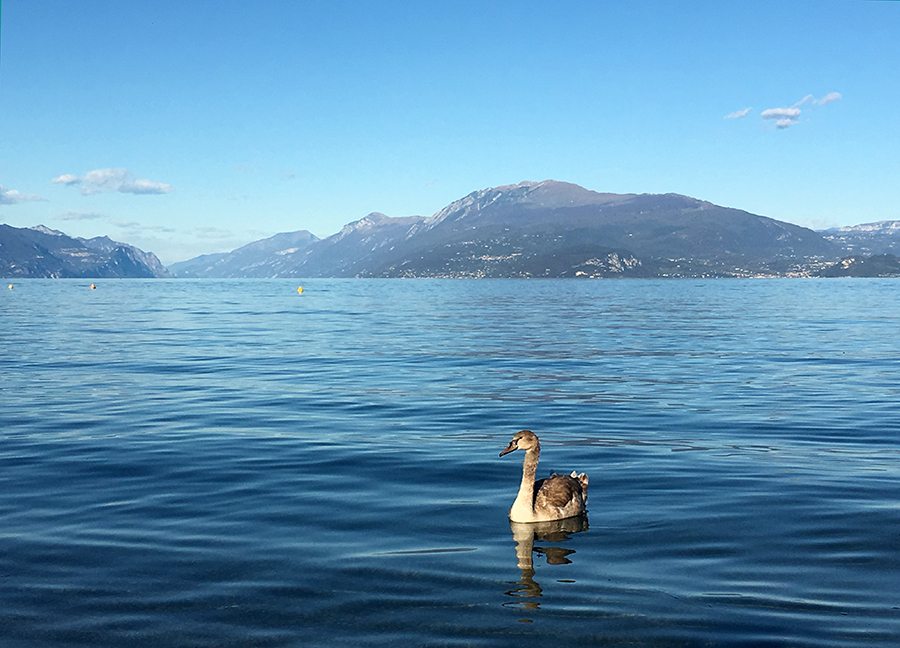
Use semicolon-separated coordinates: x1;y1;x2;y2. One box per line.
504;514;588;609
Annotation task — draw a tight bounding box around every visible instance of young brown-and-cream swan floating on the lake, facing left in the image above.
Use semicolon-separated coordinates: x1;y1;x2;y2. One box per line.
500;430;588;522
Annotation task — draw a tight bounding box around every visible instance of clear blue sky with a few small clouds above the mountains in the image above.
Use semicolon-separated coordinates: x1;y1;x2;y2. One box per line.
0;0;900;264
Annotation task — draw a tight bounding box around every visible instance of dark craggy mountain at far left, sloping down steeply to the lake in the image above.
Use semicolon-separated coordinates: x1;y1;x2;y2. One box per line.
0;224;172;279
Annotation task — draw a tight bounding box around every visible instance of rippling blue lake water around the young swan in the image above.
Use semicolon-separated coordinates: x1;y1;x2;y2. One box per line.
0;279;900;648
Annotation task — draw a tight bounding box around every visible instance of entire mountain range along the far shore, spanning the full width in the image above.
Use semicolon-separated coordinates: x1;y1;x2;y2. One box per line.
0;180;900;278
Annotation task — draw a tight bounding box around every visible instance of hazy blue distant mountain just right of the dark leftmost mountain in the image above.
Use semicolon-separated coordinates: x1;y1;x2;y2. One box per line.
169;230;319;278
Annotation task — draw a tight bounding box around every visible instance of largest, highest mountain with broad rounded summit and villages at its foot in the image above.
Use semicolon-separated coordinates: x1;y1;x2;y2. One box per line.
173;180;840;277
